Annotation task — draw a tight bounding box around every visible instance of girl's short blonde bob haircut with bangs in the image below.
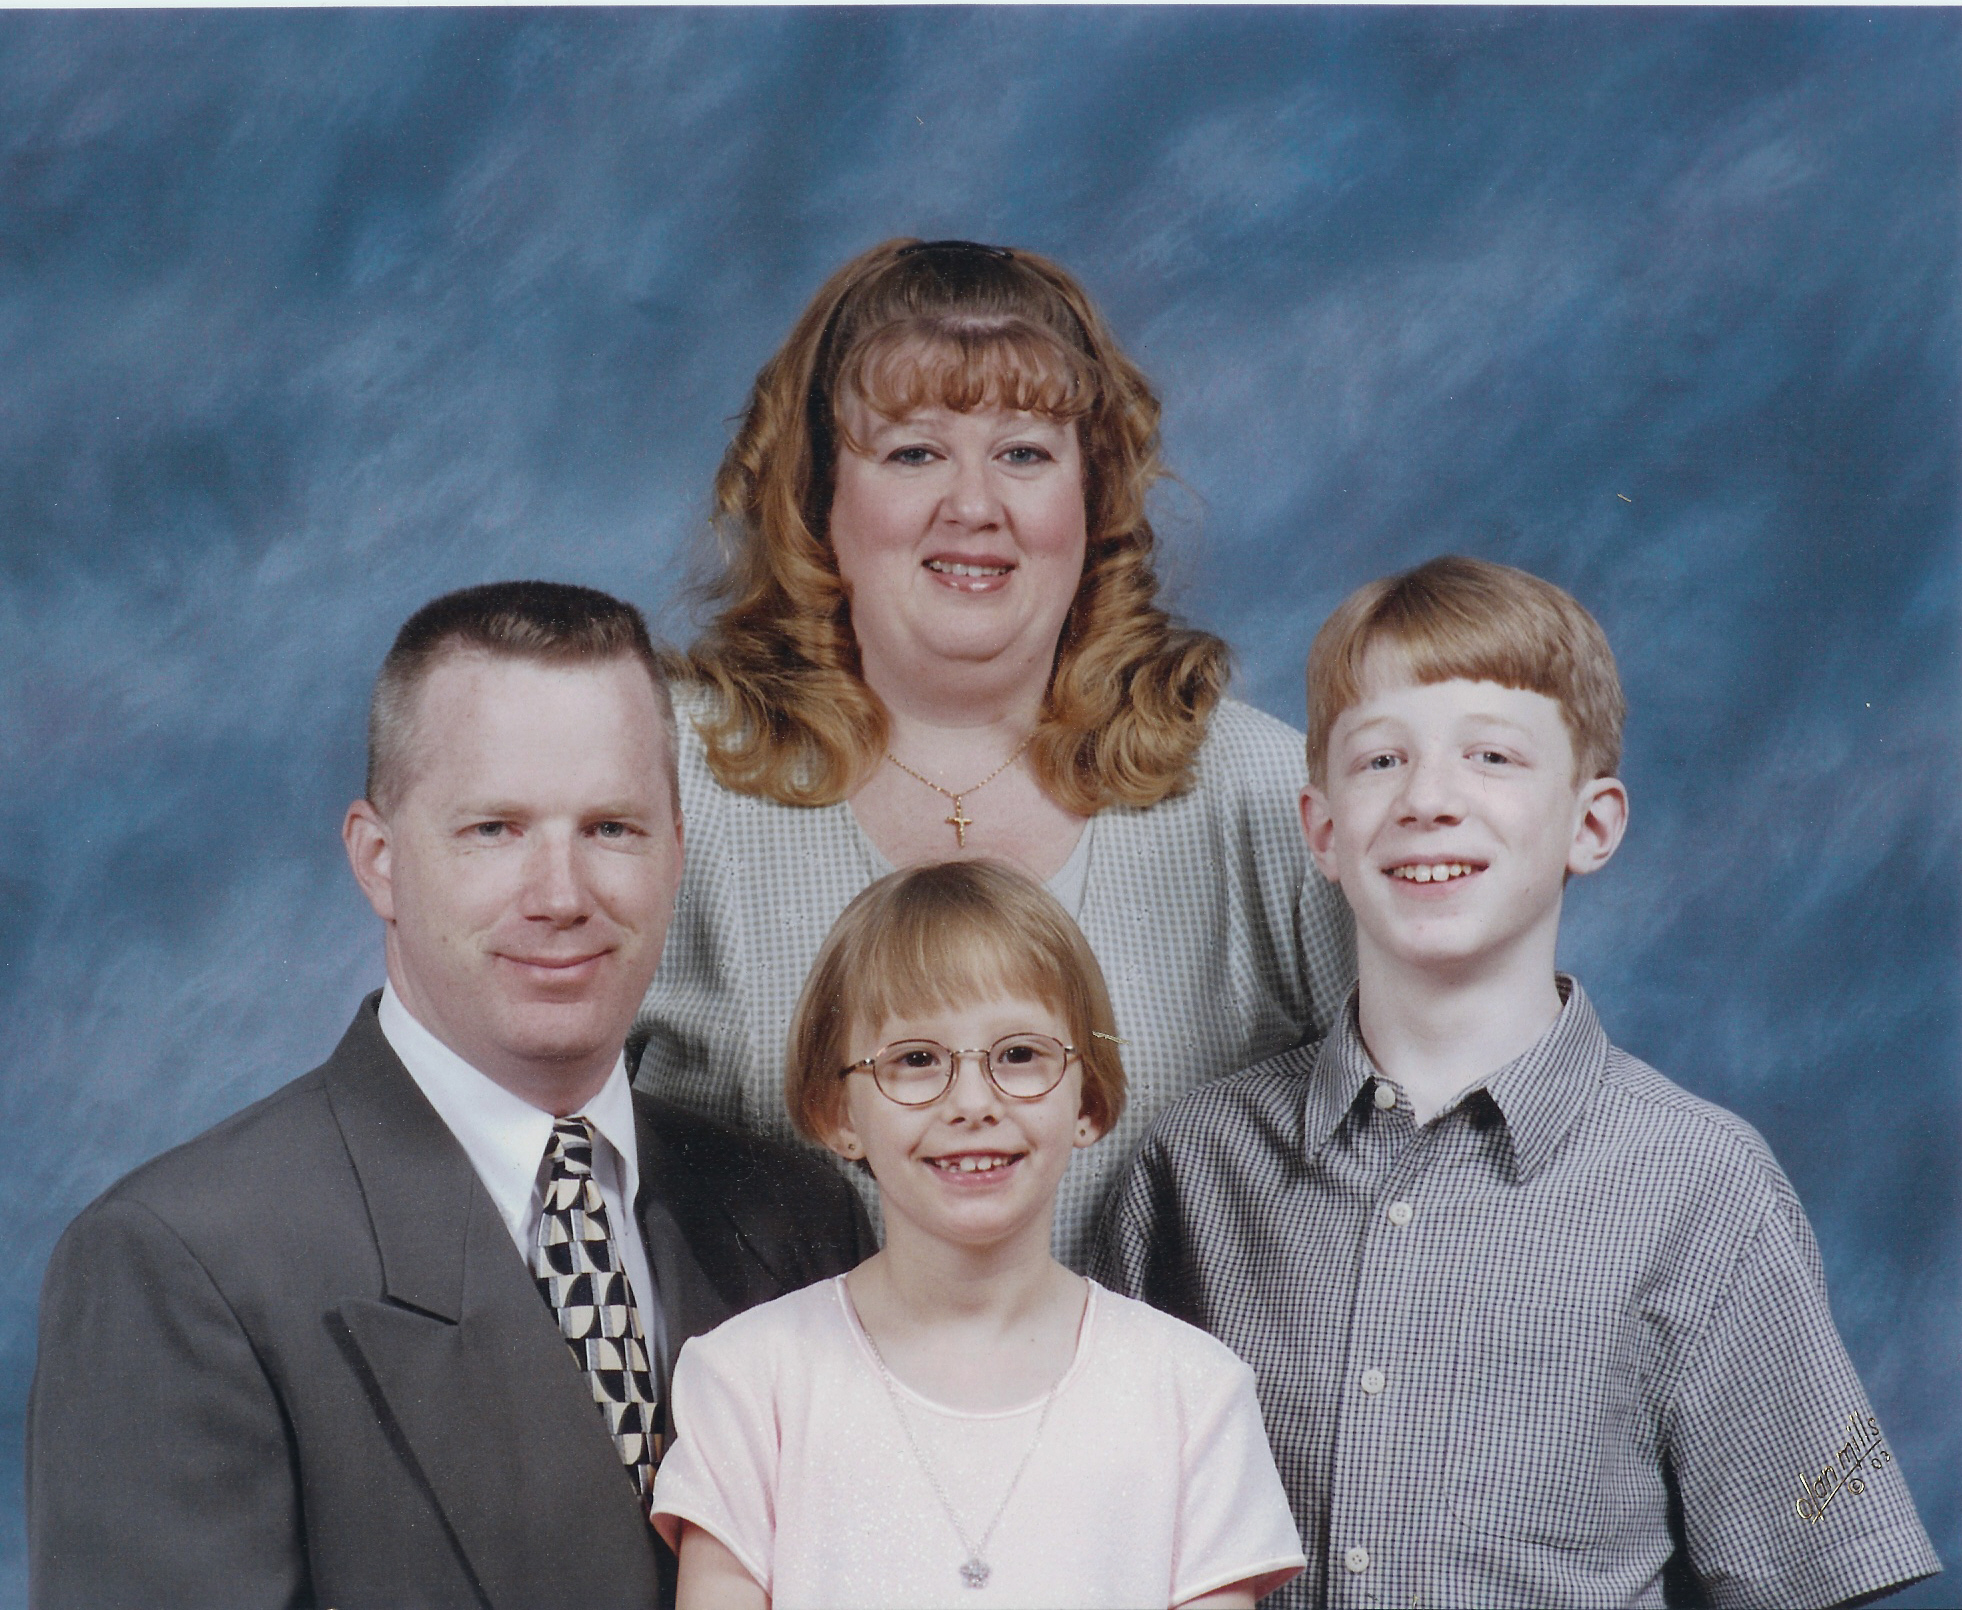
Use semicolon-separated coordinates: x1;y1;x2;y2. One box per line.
783;861;1124;1145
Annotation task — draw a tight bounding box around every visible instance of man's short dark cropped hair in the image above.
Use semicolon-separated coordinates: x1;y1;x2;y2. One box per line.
367;580;681;816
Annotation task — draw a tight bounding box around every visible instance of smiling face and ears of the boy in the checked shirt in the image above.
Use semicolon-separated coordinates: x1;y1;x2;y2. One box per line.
1301;643;1628;979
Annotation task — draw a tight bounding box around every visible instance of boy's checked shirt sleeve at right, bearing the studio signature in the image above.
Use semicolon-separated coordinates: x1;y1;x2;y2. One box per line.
1664;1179;1940;1606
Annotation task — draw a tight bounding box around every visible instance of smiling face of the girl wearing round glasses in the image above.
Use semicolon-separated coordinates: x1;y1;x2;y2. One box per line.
830;996;1099;1251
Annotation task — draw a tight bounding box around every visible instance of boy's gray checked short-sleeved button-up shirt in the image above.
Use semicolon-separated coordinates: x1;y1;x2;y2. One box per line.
1095;979;1940;1610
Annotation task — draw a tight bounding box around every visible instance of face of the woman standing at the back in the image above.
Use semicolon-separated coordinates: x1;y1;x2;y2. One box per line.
830;374;1087;686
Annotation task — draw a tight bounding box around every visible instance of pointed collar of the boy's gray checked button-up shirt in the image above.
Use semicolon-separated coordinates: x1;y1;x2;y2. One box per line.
1303;973;1609;1182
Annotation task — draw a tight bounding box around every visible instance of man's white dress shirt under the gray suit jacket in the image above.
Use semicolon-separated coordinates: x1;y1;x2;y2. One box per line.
379;984;667;1371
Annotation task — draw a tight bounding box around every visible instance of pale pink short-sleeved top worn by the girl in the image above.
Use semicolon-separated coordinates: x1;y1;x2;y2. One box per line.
653;1277;1305;1610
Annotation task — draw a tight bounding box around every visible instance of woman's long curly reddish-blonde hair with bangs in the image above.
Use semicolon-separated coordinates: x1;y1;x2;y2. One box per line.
677;239;1228;816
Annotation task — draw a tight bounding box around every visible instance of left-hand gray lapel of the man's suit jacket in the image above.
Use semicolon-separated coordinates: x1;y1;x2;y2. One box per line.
326;1002;655;1610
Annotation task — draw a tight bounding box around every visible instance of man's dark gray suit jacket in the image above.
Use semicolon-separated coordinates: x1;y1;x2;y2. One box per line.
27;996;871;1610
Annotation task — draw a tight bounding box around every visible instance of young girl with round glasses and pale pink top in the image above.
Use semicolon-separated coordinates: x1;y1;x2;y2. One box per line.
653;861;1303;1610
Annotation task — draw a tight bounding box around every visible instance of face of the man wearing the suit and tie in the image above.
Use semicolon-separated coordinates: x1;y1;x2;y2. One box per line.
349;653;681;1110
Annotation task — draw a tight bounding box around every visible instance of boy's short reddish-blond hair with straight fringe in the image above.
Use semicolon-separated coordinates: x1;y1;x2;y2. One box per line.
1309;553;1626;786
